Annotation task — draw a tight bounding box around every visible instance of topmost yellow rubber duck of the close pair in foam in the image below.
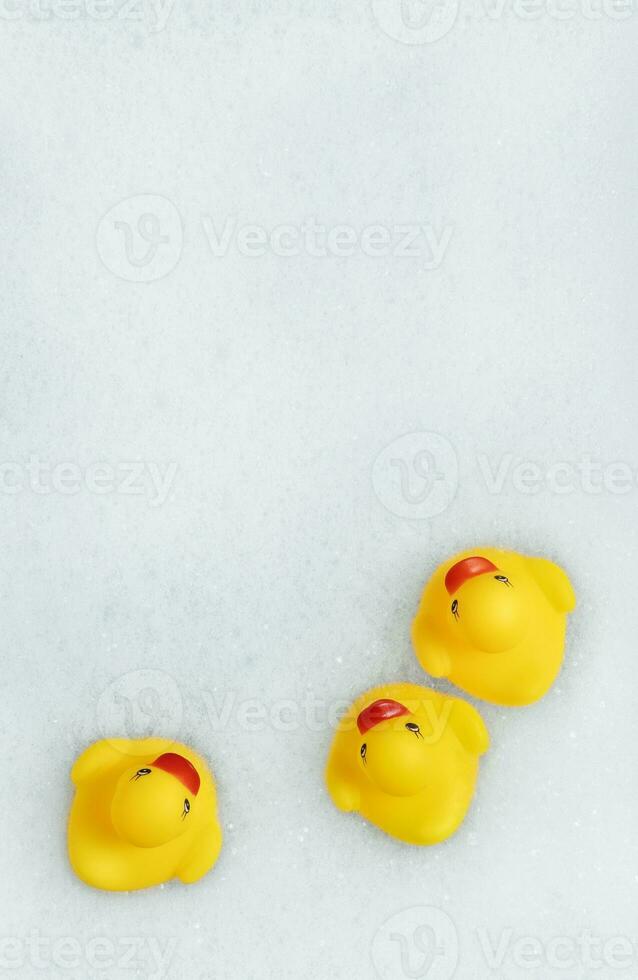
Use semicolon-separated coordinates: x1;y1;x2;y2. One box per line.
412;548;576;707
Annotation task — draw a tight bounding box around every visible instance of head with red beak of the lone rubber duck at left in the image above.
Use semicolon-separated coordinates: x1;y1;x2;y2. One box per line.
111;752;200;847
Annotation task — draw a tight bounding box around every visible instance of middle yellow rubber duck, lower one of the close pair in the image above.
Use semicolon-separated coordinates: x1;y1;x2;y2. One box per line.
326;684;489;844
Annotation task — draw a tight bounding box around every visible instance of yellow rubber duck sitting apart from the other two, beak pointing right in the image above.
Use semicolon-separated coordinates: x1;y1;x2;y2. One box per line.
68;738;222;891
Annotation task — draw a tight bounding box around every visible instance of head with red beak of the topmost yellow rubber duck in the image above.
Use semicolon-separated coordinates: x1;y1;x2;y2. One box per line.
445;555;533;653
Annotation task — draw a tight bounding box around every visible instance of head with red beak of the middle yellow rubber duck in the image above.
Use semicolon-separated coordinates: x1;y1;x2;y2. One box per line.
357;699;428;796
